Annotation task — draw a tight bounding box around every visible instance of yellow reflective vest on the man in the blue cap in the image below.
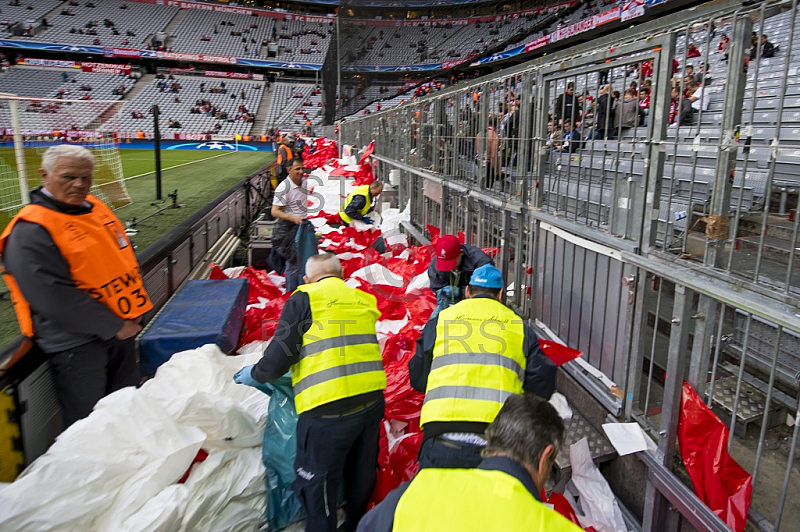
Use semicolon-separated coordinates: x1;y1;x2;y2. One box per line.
420;297;527;426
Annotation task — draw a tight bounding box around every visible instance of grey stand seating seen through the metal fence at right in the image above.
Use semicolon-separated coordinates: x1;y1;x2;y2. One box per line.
528;5;800;241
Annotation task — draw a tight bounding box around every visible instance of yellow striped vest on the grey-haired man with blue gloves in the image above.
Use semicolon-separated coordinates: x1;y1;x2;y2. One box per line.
292;277;386;414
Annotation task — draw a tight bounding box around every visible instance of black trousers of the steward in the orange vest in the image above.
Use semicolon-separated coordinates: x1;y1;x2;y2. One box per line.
50;338;141;428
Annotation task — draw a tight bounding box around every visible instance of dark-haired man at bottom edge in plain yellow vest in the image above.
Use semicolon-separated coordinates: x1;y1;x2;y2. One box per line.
358;394;581;532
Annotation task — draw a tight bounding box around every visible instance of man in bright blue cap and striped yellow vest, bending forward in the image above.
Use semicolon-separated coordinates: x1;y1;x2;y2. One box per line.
408;264;556;469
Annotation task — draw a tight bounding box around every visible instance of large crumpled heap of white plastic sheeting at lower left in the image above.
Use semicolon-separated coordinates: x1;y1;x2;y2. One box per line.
0;345;269;532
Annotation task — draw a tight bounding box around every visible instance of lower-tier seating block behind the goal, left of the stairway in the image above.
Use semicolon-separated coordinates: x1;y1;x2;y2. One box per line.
0;67;136;129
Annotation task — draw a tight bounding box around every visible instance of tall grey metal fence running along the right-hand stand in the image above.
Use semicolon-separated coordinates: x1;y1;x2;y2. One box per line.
341;0;800;530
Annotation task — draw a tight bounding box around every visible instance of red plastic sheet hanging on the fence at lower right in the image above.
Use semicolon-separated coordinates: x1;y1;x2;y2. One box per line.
678;381;753;532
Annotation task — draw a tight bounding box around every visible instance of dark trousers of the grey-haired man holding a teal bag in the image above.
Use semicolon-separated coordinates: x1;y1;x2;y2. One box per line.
292;398;384;532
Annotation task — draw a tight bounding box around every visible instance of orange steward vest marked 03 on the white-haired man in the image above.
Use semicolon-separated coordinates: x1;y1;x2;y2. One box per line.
0;195;153;337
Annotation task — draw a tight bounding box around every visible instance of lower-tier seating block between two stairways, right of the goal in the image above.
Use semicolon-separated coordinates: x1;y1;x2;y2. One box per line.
114;76;264;137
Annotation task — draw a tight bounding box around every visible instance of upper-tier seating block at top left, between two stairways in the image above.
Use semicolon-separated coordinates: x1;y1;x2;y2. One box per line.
23;0;179;48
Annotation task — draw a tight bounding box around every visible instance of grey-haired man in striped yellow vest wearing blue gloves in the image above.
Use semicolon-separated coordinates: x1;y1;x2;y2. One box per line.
234;253;386;532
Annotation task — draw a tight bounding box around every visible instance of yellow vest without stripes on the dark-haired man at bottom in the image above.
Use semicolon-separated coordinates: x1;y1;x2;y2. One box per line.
392;468;581;532
